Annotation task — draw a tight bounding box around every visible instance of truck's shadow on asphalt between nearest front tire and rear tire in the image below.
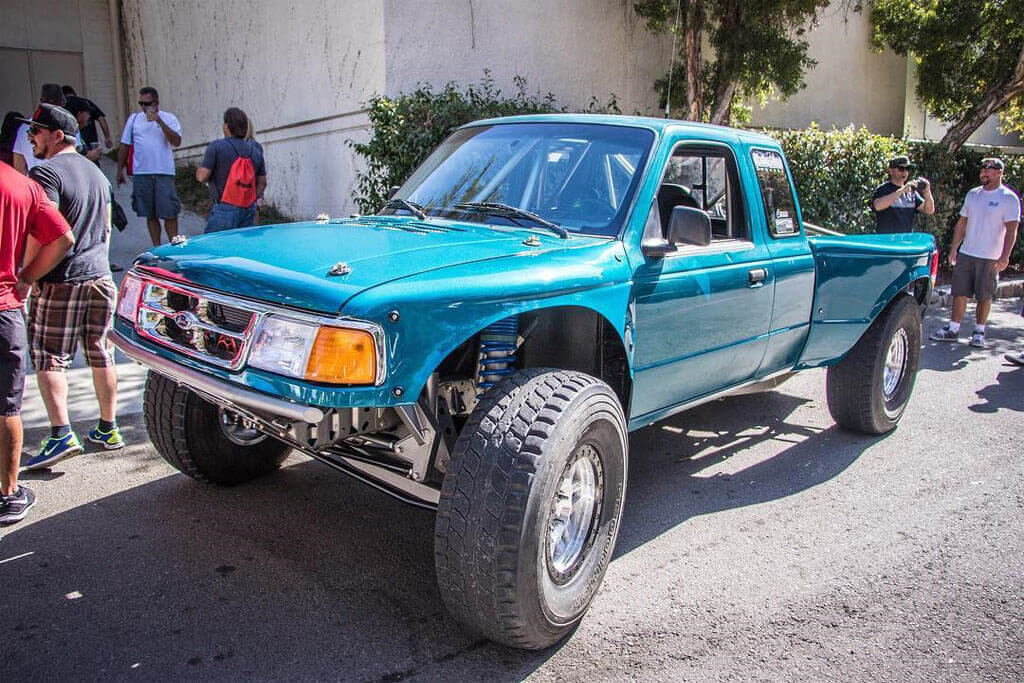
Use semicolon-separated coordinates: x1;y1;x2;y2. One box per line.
616;392;884;556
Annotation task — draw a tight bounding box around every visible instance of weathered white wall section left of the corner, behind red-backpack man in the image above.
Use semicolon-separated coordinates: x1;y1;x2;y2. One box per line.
122;0;385;218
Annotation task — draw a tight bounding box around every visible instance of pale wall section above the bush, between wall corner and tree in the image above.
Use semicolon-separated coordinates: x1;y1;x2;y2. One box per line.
384;0;672;114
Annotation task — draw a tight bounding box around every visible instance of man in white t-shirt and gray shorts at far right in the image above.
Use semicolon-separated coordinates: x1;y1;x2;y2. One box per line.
930;158;1021;348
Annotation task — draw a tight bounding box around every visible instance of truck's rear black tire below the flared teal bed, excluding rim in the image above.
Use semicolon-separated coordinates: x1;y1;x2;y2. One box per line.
825;295;921;434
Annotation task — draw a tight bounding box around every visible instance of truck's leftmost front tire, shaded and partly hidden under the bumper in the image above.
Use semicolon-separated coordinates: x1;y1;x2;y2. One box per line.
142;371;290;486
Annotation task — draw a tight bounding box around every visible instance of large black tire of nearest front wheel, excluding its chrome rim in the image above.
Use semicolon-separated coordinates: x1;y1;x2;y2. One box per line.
434;369;629;649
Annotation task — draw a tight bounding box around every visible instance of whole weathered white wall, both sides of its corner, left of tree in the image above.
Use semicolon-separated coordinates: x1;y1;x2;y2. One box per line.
114;0;670;218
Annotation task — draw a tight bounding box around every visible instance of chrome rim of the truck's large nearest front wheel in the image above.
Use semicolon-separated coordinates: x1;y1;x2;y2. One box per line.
547;444;603;584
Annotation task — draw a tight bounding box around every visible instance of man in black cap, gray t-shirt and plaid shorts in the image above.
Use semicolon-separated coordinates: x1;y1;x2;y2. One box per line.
17;104;124;469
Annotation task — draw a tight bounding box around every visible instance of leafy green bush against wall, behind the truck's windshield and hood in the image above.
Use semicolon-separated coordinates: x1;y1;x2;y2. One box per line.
348;70;621;213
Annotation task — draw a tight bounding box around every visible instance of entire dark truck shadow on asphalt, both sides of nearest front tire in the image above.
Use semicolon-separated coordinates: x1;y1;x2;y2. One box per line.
0;393;877;681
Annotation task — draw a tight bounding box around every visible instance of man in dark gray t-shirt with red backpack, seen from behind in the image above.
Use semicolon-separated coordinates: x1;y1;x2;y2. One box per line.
196;106;266;232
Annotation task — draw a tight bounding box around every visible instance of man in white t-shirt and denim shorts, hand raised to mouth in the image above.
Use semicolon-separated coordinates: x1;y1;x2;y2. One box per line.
118;86;181;246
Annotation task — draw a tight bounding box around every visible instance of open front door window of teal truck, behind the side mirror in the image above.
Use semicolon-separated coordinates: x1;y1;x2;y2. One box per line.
657;146;746;242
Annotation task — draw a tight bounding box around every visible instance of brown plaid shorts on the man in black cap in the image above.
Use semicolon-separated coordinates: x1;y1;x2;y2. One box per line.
29;276;118;372
